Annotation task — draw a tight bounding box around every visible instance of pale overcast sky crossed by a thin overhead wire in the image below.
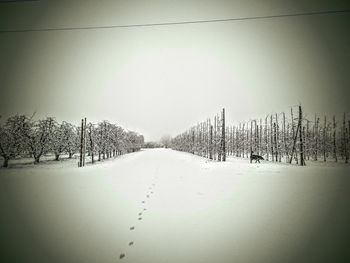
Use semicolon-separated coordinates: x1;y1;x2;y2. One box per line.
0;0;350;140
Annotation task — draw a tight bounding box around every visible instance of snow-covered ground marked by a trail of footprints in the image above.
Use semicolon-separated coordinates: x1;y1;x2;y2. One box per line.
0;149;350;263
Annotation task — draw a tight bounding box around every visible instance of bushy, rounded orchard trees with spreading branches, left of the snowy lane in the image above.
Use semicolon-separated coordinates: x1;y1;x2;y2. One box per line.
0;115;144;167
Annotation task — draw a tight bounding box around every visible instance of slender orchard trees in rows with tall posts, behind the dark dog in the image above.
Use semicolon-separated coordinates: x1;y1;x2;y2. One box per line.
171;106;350;165
